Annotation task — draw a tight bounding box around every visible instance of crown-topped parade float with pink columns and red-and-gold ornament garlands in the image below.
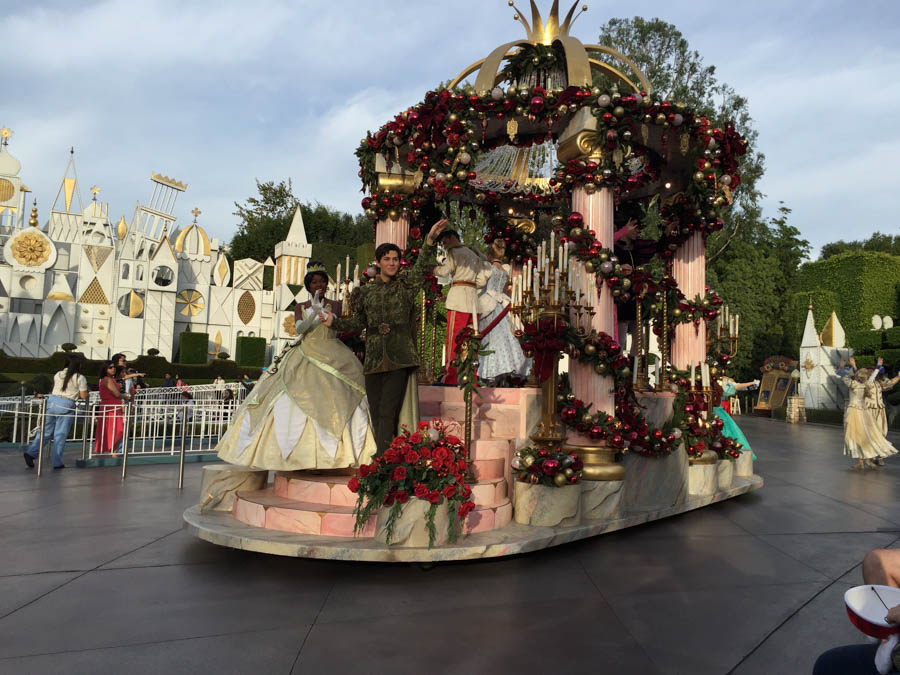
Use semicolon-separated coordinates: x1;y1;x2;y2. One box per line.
184;0;762;563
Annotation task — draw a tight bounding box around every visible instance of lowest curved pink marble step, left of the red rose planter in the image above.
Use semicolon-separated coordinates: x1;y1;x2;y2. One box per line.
233;490;375;537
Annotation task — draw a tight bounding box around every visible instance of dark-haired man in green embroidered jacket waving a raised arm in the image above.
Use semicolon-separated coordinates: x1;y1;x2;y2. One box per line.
324;220;447;454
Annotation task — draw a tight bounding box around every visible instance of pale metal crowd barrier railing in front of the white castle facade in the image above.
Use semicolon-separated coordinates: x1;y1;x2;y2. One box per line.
13;390;239;488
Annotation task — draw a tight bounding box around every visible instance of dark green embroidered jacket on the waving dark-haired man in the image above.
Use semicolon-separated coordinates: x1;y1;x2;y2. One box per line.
332;243;435;375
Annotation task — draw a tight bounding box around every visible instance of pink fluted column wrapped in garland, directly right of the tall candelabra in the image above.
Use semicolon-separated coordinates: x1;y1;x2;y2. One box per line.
569;188;616;426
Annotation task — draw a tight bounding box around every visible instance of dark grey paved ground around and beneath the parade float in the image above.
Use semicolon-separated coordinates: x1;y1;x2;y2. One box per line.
0;417;900;675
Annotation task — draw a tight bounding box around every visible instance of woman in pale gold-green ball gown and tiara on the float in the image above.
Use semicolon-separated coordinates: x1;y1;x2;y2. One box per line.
217;262;375;471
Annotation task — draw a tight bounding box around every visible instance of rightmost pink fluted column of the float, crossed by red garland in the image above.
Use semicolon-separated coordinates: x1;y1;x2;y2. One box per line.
671;232;706;370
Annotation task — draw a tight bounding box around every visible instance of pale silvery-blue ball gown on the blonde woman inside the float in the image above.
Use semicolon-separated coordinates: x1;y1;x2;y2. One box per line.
478;266;531;380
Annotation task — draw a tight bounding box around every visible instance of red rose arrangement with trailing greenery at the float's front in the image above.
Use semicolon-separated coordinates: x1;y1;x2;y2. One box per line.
347;420;475;546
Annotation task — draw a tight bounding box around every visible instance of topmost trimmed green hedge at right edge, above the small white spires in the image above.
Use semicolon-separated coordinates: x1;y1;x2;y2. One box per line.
796;251;900;332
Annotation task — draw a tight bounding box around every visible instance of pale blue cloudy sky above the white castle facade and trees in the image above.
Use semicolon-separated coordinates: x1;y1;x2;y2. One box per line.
0;0;900;256
